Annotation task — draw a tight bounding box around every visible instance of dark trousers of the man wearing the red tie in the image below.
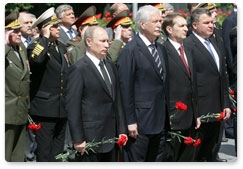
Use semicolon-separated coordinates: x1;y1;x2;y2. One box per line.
165;129;198;162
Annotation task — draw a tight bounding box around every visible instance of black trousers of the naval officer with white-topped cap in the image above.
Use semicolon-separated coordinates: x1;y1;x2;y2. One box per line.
34;116;67;162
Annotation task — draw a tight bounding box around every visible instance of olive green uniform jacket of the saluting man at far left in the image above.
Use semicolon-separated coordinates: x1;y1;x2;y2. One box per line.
5;45;30;125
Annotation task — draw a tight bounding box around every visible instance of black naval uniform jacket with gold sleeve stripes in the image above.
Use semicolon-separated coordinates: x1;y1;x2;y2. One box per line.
27;37;68;118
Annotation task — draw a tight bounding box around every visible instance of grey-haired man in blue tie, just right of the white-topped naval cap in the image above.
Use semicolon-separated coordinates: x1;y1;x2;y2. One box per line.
55;4;78;45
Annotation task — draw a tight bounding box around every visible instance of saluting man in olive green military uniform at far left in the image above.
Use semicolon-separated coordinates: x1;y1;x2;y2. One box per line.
5;12;30;162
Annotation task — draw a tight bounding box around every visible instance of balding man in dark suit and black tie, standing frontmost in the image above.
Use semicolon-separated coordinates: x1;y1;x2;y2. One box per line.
66;26;127;162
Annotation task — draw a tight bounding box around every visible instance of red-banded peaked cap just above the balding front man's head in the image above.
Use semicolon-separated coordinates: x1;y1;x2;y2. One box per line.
73;6;98;28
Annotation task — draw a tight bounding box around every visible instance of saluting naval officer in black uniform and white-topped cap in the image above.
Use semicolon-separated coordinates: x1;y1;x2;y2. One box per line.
27;7;68;162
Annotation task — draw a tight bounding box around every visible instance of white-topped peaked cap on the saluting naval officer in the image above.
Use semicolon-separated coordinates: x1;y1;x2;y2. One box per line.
32;7;60;29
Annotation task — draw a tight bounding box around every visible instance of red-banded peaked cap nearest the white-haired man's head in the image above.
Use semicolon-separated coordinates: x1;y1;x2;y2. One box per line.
106;10;132;29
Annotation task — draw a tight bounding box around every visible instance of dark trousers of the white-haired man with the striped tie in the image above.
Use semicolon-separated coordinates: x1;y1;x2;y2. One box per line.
122;132;166;162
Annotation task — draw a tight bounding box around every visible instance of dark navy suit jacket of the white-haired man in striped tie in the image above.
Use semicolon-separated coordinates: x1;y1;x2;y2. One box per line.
117;35;169;134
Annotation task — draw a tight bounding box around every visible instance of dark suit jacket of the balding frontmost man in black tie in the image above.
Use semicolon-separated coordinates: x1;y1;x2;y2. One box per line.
66;55;127;153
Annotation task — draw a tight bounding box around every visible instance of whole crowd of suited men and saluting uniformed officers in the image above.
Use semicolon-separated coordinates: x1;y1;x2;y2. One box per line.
5;3;237;162
